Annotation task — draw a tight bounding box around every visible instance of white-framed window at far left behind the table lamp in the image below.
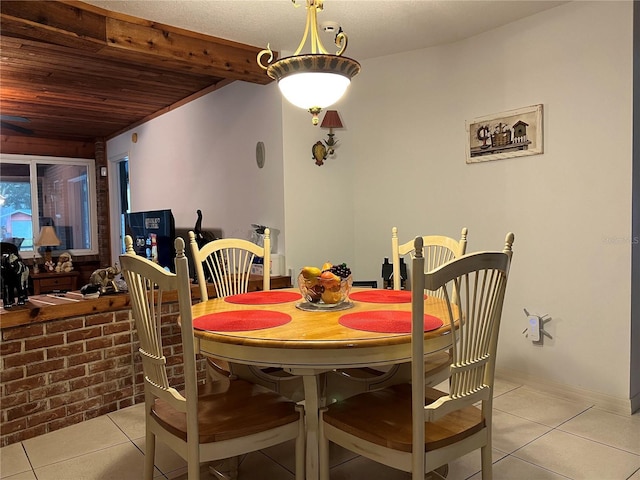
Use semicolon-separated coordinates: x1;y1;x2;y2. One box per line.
0;155;98;255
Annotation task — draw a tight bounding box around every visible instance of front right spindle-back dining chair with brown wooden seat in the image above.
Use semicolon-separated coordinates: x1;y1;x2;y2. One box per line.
319;233;514;480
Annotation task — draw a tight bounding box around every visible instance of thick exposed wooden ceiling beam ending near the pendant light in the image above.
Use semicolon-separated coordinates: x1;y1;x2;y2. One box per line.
0;0;271;85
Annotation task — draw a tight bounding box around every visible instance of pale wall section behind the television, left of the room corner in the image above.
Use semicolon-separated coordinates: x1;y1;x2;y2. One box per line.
107;82;285;246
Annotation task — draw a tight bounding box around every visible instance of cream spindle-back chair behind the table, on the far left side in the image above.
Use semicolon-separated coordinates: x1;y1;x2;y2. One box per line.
189;228;304;401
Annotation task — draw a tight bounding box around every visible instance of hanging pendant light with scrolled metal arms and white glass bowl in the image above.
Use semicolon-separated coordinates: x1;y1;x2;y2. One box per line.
258;0;360;125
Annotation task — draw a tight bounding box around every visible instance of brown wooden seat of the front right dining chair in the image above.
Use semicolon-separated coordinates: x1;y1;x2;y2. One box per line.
323;383;485;452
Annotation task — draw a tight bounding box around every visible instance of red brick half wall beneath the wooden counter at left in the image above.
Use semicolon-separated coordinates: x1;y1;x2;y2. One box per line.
0;303;206;447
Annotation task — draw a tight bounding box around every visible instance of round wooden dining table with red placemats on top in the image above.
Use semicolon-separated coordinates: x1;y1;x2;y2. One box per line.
192;288;451;480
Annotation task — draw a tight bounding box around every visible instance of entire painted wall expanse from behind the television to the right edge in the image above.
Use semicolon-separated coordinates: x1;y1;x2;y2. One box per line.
107;2;637;408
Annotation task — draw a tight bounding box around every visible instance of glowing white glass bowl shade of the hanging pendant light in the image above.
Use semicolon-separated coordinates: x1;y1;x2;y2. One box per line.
278;72;351;110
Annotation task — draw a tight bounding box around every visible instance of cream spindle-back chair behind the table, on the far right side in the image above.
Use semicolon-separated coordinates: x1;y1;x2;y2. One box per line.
329;227;468;393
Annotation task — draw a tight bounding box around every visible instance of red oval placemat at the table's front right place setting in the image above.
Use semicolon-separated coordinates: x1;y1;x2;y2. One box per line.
338;310;442;333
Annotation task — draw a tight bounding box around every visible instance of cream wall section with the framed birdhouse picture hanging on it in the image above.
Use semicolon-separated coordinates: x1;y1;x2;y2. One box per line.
341;2;632;399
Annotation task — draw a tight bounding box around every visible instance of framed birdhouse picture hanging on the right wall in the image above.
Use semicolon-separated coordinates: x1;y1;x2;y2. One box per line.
466;104;544;163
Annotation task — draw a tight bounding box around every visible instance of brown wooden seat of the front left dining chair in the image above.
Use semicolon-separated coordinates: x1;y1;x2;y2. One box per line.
151;379;300;443
